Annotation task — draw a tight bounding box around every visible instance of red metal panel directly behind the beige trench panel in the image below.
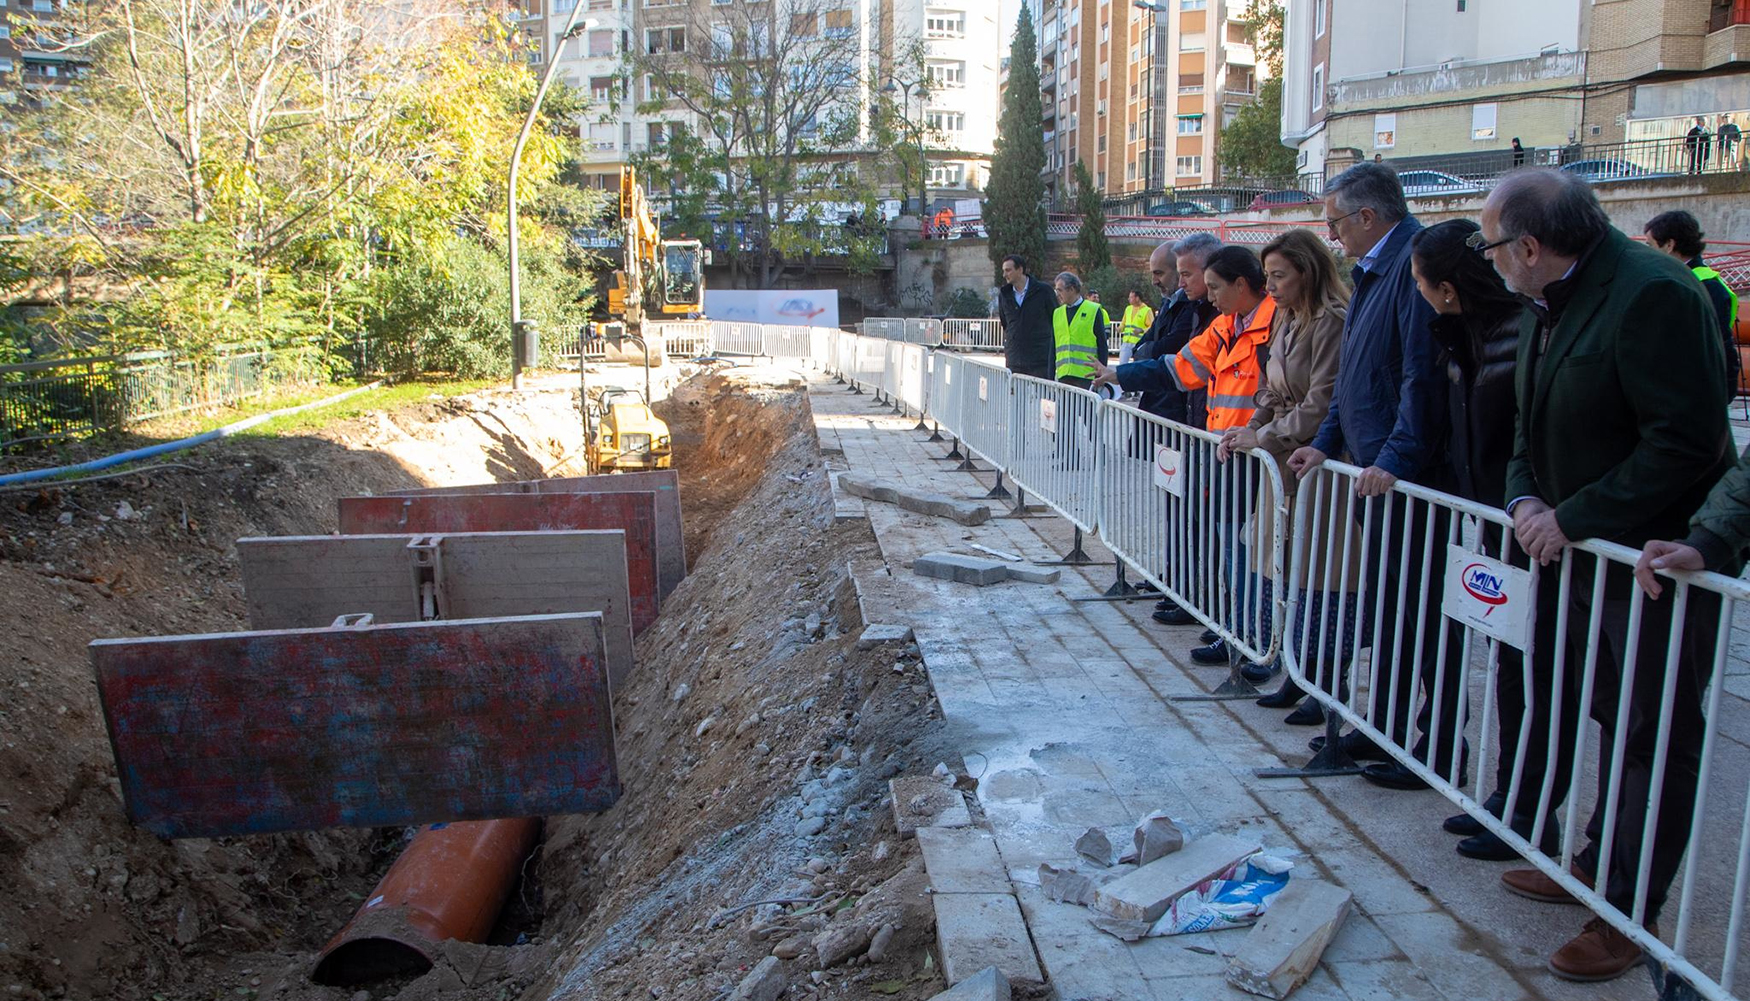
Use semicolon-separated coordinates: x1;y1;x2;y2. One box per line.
340;494;660;634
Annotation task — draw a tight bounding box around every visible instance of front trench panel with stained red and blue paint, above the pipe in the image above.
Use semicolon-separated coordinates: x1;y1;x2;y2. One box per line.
91;613;620;838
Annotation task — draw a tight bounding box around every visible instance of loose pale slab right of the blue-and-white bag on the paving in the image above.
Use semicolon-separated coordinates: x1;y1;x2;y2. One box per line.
1227;879;1355;1001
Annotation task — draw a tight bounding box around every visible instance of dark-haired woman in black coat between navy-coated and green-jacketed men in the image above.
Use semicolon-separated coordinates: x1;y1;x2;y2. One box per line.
1411;219;1556;859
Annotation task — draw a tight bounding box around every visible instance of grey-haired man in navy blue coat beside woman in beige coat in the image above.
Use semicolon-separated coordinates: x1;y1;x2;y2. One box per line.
1288;163;1465;789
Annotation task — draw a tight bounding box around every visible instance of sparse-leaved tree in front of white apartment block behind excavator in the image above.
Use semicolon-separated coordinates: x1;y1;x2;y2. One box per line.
632;0;898;289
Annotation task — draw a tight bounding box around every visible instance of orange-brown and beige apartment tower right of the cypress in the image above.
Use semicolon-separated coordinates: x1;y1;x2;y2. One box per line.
1040;0;1264;201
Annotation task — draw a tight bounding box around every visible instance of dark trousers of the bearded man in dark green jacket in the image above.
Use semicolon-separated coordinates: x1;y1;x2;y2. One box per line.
1566;557;1720;922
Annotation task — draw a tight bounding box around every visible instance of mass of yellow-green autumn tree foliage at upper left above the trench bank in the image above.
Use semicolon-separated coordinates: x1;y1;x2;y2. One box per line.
0;0;600;375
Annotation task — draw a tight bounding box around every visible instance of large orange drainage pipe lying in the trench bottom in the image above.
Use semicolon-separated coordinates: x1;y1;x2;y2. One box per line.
310;817;541;987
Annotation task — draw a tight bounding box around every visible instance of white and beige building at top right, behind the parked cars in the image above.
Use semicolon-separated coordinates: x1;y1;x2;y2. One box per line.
1283;0;1750;182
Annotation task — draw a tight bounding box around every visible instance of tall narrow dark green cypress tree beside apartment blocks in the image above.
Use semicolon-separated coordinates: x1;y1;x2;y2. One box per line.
984;5;1045;280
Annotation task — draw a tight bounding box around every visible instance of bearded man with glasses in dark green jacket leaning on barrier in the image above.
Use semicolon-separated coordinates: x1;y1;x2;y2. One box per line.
1475;170;1733;980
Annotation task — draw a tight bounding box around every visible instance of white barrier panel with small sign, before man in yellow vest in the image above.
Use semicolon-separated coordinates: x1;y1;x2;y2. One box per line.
1008;375;1099;532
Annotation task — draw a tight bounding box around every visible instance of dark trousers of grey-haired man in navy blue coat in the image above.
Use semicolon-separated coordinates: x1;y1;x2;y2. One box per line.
1355;492;1465;781
